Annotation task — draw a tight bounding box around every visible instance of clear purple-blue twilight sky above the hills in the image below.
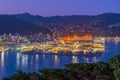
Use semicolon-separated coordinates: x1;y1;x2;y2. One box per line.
0;0;120;16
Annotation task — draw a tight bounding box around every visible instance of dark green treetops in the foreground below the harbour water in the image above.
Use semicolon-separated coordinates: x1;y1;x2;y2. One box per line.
3;55;120;80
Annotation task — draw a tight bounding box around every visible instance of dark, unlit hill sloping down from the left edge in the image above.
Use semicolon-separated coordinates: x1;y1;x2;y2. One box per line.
0;15;50;34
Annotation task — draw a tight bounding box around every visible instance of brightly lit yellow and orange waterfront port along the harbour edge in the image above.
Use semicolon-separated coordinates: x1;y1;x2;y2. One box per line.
0;36;105;56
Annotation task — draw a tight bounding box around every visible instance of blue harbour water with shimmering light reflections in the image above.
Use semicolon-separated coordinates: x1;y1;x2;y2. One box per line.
0;41;120;80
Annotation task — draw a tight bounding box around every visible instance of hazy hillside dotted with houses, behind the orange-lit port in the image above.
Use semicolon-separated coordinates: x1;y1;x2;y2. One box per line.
14;13;120;36
